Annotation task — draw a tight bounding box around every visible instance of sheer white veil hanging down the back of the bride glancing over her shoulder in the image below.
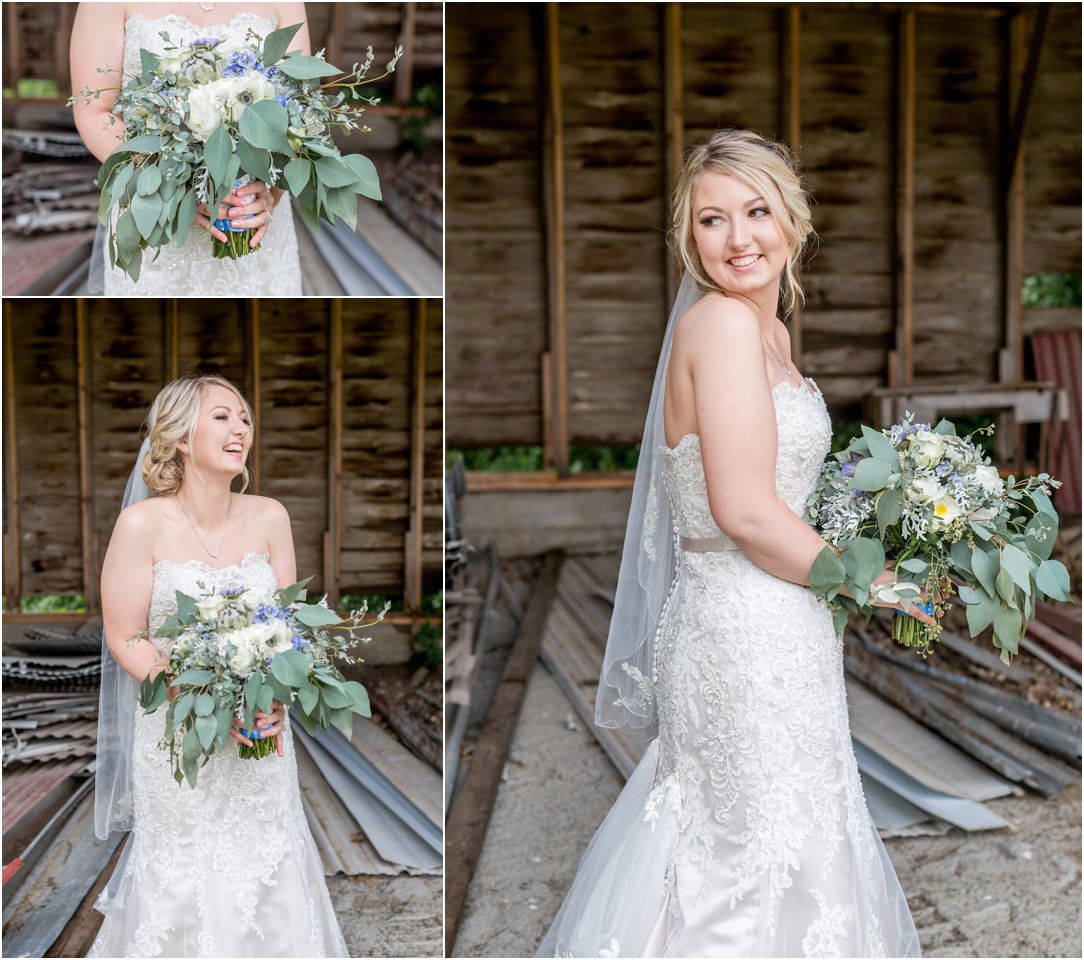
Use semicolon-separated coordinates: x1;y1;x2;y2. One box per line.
595;273;704;739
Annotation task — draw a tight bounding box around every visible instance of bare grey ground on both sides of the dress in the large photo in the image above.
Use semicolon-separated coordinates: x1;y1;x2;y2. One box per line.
454;665;1081;957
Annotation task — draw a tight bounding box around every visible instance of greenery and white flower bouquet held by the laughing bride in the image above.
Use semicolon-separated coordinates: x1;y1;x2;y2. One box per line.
140;576;387;787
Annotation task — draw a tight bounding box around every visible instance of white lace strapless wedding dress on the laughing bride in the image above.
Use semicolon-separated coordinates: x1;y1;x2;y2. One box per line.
87;554;349;957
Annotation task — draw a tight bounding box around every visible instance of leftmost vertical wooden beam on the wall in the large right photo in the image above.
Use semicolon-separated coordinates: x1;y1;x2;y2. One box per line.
543;2;569;470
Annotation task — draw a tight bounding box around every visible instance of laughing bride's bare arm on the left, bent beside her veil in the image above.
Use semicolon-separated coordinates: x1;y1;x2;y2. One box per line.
102;501;168;680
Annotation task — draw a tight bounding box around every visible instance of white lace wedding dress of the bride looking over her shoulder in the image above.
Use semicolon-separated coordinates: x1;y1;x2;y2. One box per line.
539;381;918;957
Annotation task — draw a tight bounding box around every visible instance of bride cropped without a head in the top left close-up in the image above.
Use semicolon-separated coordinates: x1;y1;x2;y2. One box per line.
72;3;310;297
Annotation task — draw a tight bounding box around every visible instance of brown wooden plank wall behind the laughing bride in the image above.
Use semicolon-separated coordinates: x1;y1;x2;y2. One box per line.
4;298;443;610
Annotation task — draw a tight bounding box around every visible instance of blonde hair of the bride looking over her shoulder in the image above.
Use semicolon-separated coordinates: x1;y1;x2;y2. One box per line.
670;128;814;316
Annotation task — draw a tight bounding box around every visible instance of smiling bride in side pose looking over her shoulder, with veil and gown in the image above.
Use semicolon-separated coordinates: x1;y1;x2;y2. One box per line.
539;130;929;957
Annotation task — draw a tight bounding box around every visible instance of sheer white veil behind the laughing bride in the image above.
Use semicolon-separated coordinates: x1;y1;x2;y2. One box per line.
94;439;151;840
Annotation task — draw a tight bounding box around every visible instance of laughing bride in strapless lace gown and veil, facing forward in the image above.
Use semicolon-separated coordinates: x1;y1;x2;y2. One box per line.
94;376;349;957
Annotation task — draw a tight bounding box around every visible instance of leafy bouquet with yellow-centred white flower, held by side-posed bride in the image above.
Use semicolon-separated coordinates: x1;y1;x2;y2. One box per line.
806;414;1069;662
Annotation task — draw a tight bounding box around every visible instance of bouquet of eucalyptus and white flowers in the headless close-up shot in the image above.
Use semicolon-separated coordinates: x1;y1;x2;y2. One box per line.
68;24;402;281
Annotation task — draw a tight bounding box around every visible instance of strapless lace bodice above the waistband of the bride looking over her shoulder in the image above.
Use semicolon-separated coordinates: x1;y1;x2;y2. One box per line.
662;380;831;537
